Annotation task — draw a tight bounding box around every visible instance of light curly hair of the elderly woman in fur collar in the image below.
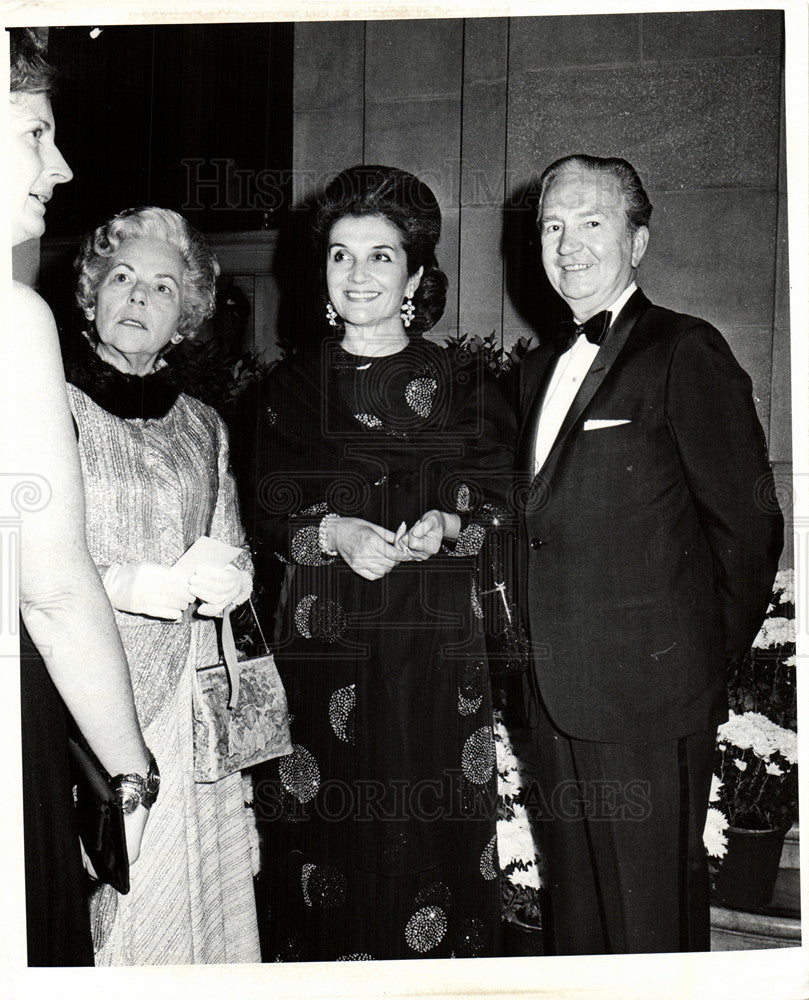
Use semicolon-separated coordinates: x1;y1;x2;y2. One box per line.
74;207;219;337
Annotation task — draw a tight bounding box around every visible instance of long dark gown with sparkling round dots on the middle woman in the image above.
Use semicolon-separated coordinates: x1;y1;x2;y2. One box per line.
245;340;515;961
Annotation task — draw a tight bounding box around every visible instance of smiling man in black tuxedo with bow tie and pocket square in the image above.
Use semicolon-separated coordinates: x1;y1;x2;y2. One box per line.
519;155;783;954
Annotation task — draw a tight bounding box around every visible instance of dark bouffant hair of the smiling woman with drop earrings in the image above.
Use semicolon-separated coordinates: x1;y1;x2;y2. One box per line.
314;165;447;334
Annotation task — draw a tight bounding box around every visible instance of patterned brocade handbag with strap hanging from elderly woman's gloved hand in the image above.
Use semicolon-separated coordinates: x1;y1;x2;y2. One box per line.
193;601;292;782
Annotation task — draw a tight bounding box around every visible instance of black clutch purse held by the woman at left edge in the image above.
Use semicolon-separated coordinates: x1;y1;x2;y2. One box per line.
68;737;129;895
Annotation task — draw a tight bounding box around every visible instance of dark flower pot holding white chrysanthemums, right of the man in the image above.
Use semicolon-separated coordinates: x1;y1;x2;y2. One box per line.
713;826;788;910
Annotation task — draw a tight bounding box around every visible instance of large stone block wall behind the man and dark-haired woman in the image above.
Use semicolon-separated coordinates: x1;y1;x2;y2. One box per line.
294;10;791;540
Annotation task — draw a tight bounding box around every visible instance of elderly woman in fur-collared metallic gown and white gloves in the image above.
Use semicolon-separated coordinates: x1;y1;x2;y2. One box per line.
68;208;259;965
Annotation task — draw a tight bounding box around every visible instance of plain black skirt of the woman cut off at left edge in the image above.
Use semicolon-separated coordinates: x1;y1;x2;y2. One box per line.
20;619;93;966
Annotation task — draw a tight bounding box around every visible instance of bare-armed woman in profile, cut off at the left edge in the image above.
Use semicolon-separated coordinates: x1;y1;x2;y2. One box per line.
8;28;150;966
